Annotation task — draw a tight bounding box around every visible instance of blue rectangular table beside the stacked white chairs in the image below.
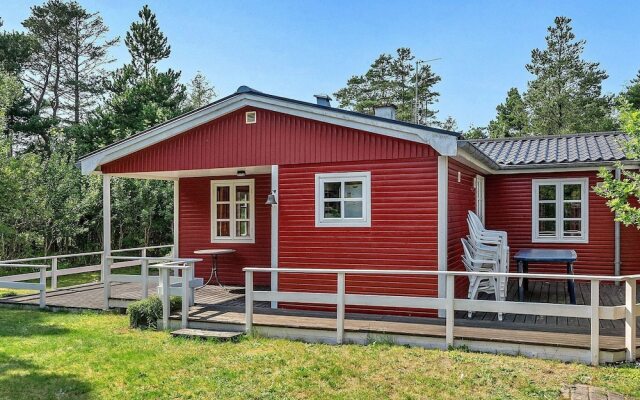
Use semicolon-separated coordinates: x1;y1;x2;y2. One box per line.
514;249;578;304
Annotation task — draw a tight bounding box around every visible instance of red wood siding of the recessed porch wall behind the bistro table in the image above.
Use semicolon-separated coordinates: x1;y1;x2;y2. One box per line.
178;175;271;285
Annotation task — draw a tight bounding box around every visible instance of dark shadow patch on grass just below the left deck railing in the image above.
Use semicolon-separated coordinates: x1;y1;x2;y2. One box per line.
0;308;69;337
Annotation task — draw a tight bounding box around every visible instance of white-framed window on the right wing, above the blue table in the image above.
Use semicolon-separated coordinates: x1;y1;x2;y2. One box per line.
532;178;589;243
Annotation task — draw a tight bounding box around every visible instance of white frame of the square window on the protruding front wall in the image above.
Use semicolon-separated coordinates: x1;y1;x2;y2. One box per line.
315;171;371;228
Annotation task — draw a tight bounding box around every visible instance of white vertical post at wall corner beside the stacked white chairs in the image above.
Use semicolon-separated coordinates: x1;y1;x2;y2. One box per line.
438;156;449;318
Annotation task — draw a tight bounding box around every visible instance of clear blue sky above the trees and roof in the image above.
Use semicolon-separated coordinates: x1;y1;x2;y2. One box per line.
0;0;640;129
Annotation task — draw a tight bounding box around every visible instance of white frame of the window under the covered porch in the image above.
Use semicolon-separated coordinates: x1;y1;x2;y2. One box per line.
211;179;256;243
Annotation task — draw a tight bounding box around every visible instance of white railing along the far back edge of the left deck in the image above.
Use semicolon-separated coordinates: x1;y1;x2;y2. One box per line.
0;245;173;289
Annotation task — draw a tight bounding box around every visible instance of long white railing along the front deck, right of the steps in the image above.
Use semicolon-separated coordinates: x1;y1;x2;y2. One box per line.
244;268;640;365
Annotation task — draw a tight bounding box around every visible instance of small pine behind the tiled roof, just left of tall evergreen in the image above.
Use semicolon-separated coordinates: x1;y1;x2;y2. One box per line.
488;88;529;138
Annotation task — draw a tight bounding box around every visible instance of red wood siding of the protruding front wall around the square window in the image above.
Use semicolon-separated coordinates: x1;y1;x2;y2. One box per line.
279;158;438;315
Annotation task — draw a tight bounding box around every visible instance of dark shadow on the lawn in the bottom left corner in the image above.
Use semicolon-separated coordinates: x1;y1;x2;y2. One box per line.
0;353;91;400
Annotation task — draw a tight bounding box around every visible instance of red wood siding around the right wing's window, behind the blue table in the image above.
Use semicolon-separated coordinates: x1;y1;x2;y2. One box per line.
486;172;625;275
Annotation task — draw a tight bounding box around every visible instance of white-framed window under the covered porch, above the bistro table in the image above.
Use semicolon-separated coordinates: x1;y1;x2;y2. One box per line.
211;179;255;243
